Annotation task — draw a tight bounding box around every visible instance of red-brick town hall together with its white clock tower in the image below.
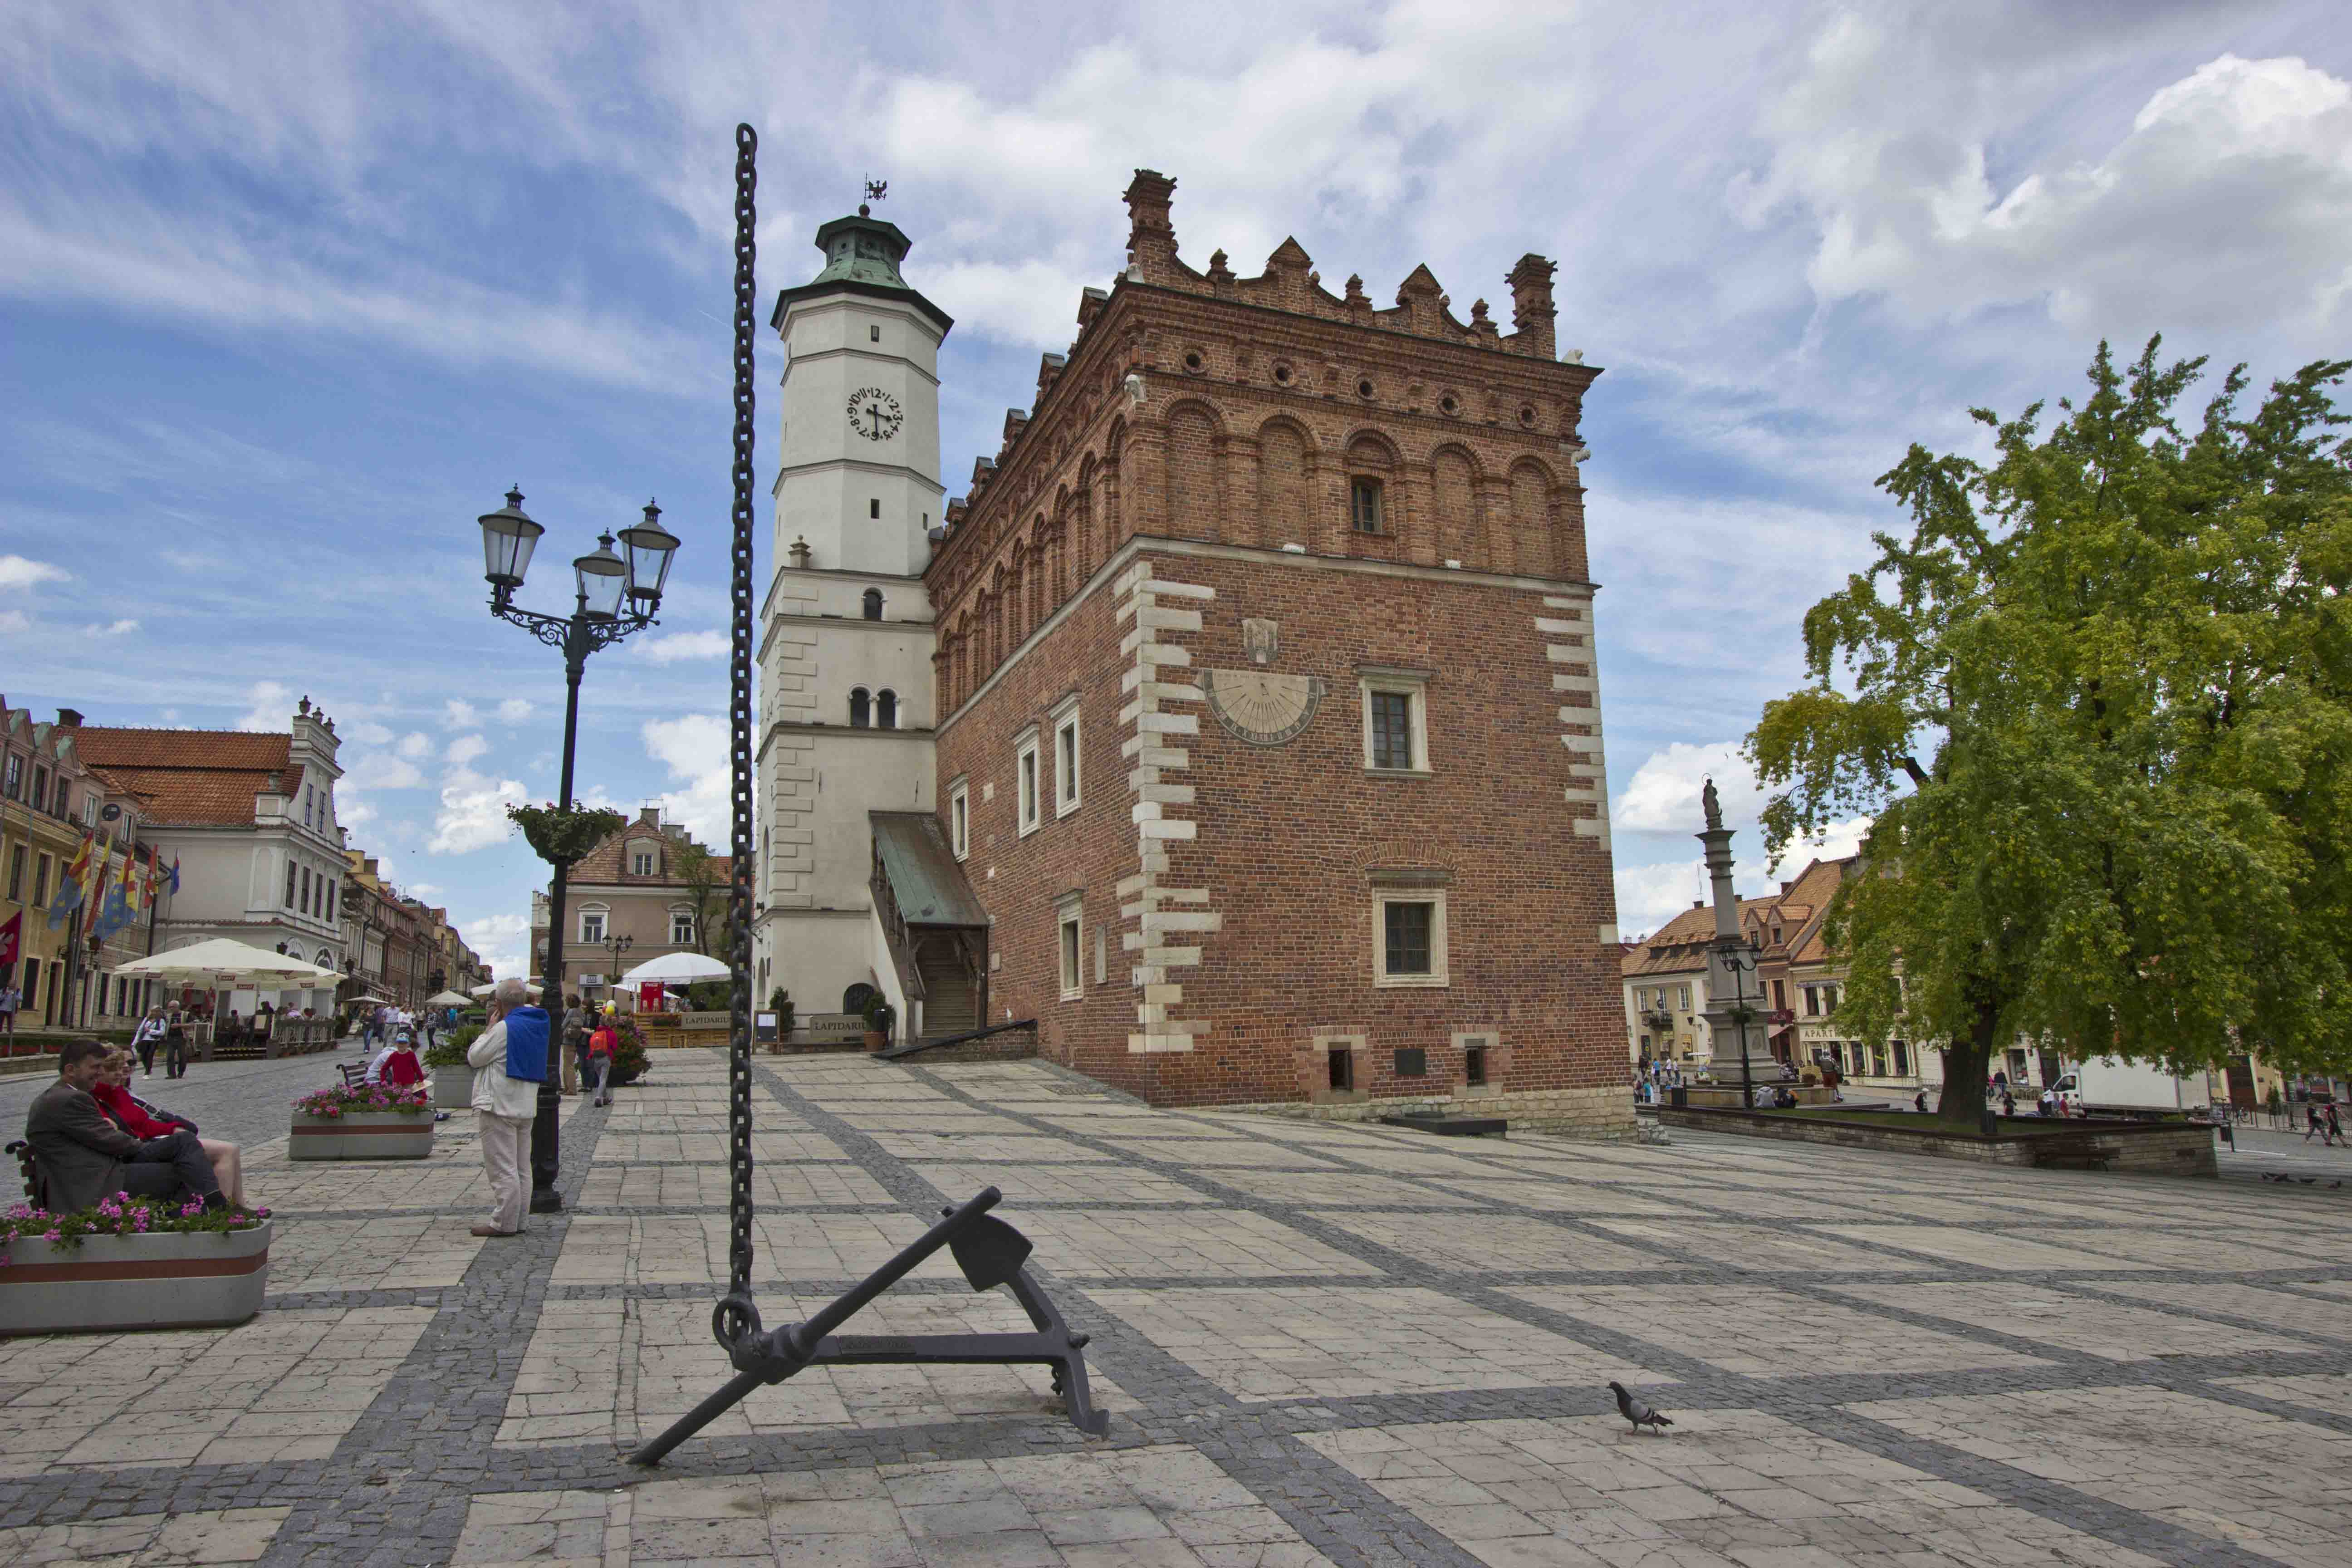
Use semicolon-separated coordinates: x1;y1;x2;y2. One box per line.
755;169;1630;1131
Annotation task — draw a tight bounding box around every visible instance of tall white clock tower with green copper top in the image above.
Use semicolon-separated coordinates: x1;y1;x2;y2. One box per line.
753;207;953;1018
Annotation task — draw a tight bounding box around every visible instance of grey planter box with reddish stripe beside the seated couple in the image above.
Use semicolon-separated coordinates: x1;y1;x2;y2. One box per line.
0;1220;273;1338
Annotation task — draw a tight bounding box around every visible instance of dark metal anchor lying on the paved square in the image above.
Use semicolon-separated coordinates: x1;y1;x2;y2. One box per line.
630;1187;1110;1465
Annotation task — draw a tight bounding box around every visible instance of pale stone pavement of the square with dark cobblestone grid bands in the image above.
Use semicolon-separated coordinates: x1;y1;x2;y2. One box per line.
0;1051;2352;1568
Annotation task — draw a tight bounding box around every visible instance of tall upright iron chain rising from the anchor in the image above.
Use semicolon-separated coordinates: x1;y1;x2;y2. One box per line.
710;125;760;1349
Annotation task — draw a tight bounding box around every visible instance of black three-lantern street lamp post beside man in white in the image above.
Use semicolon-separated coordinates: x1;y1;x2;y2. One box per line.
468;489;677;1213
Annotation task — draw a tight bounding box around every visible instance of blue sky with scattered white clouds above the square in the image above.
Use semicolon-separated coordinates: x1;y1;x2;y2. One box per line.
0;0;2352;971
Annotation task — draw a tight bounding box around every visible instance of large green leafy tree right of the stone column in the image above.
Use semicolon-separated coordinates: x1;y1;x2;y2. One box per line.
1748;341;2352;1122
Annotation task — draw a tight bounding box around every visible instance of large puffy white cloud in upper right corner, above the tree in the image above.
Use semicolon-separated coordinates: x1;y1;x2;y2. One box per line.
1731;30;2352;343
